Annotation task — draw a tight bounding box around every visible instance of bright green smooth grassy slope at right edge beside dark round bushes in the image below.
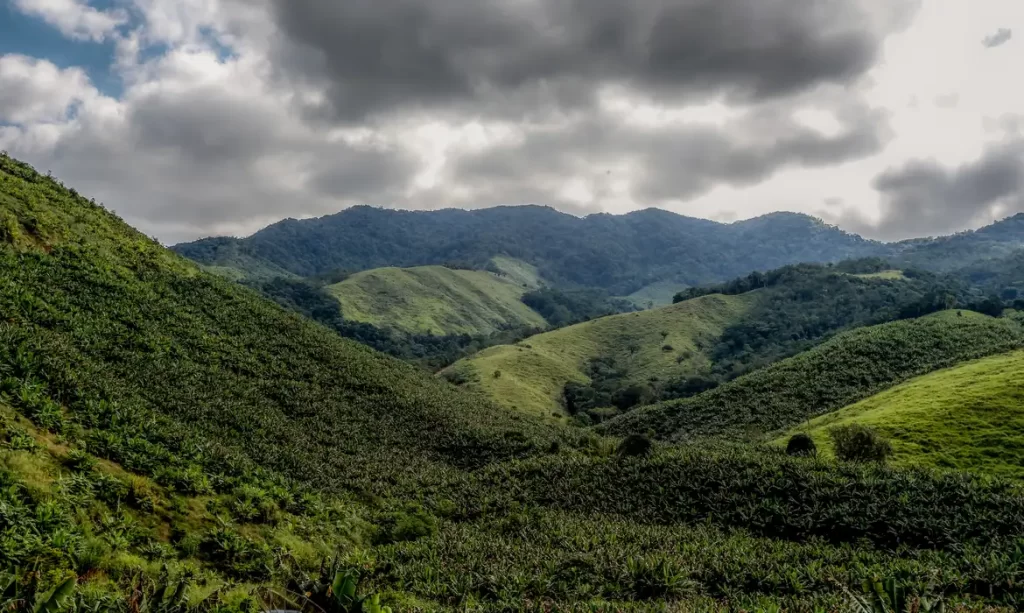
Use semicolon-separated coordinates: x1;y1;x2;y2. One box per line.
780;351;1024;479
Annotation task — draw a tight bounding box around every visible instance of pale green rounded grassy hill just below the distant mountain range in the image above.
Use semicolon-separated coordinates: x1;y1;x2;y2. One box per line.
326;266;547;336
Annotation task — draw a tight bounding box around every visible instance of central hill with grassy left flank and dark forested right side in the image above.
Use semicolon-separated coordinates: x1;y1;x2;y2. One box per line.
450;260;963;433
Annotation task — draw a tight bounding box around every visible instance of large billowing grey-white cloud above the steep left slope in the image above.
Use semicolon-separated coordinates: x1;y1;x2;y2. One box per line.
0;50;413;242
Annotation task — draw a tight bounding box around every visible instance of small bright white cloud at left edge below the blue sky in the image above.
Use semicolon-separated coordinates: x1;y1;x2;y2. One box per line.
0;55;96;124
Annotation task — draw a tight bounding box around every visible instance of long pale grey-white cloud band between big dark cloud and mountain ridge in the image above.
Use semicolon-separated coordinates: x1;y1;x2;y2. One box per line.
445;92;888;212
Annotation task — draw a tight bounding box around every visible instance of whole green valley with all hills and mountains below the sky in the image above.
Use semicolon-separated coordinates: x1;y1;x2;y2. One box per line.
6;155;1024;613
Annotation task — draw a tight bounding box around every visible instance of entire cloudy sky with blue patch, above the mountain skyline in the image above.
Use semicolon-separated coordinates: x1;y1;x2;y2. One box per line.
0;0;1024;244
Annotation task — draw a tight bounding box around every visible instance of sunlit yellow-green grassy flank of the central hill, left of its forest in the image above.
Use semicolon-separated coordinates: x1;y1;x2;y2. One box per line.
444;292;757;417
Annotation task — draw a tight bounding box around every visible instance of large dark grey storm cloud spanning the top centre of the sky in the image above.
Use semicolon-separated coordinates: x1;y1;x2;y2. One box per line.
271;0;916;121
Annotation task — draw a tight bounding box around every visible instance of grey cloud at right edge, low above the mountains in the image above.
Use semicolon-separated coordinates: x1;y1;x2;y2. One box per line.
843;138;1024;239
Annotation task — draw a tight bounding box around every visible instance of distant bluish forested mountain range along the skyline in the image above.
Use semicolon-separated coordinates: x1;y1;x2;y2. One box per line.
174;207;884;296
